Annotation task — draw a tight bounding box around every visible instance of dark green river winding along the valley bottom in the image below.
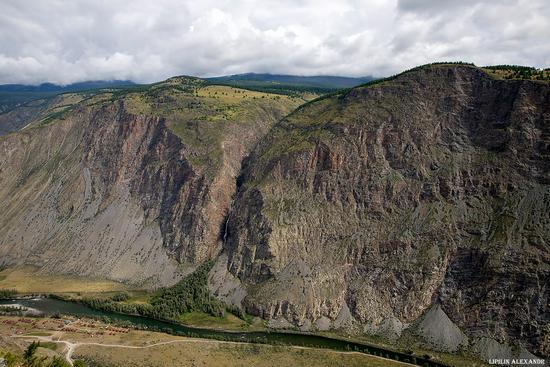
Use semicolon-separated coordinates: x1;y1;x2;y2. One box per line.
0;298;445;367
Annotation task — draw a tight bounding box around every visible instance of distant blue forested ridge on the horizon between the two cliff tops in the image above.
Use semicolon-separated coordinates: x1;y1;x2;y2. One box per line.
206;73;374;93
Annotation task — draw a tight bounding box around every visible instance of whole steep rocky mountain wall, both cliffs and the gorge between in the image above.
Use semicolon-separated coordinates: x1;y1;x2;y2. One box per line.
0;64;550;358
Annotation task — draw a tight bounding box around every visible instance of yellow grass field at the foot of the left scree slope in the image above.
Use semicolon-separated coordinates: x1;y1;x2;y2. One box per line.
0;266;128;293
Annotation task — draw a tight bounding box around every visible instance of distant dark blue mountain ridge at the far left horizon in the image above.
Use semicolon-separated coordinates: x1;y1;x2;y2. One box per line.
0;80;136;113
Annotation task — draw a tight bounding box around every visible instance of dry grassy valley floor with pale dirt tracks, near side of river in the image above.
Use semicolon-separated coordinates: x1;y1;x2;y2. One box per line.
0;316;409;367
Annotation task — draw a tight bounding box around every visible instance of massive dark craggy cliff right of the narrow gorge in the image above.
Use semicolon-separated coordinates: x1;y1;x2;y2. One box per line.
225;66;550;350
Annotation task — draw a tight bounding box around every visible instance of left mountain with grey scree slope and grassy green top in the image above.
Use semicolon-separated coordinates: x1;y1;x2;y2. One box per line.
0;79;300;287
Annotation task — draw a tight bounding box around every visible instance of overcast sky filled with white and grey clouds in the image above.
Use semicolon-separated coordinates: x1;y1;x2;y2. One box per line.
0;0;550;84
